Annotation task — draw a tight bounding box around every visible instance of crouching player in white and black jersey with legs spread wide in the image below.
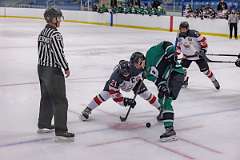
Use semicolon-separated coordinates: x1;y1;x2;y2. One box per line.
80;52;160;121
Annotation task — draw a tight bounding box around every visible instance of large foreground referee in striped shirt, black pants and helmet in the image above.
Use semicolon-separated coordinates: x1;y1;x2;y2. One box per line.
38;8;74;139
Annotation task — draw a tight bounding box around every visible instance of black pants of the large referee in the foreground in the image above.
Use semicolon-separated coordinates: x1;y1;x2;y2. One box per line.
38;65;68;132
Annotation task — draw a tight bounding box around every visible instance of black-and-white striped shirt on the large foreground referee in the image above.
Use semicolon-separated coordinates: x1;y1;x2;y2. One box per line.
38;25;69;70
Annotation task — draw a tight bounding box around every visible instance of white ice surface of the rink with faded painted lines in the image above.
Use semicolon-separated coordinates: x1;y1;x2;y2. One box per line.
0;18;240;160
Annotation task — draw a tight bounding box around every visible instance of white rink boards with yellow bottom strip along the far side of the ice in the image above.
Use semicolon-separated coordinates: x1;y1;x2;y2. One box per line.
0;7;236;37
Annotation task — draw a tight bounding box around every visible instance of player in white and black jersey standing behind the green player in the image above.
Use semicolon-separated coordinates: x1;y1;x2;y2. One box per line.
176;22;220;89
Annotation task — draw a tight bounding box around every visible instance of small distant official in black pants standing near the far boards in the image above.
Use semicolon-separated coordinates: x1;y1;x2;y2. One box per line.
228;10;239;39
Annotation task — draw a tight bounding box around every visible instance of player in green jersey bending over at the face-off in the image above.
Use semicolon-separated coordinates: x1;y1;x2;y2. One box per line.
145;41;184;141
